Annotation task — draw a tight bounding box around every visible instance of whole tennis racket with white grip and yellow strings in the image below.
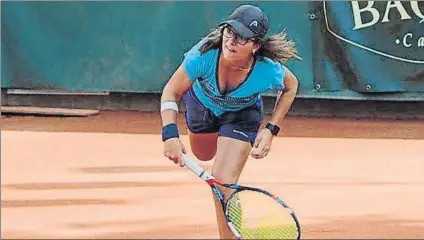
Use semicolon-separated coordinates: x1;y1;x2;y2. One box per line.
183;154;300;239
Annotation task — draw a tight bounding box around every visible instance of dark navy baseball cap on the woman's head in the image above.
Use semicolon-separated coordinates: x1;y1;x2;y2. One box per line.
219;5;269;38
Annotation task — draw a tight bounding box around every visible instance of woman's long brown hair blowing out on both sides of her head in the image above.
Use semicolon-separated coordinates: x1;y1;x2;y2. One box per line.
200;26;301;63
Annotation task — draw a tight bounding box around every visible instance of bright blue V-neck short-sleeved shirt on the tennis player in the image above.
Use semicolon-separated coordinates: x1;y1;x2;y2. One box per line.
183;40;285;116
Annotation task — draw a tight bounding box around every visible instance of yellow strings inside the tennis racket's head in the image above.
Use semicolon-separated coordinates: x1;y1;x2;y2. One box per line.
227;190;298;239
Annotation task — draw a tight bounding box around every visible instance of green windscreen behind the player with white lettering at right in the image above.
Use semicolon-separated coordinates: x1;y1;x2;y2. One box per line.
1;1;424;99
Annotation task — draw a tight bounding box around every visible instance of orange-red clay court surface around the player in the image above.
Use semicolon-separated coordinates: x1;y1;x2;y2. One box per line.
1;112;424;239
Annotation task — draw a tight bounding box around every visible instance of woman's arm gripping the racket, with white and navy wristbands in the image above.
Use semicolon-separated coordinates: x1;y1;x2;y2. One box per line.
161;65;191;166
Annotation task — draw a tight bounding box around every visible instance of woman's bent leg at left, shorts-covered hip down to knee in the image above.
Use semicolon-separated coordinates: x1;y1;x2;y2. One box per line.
183;89;218;161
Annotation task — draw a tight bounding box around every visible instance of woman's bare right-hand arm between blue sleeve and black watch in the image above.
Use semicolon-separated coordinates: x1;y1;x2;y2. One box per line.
269;67;299;126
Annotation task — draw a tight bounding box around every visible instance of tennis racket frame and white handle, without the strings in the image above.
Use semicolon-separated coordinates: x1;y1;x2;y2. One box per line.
182;154;301;239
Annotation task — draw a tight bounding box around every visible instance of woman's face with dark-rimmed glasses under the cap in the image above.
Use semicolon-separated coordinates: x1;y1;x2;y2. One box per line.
222;26;259;61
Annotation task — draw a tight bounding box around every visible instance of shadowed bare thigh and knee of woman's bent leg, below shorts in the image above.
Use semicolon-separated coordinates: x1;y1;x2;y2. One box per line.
188;130;218;161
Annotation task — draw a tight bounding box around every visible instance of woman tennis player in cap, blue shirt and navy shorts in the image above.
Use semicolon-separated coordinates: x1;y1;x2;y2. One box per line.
161;5;298;239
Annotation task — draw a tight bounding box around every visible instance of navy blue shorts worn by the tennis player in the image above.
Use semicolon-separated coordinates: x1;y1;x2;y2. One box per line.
183;88;264;144
